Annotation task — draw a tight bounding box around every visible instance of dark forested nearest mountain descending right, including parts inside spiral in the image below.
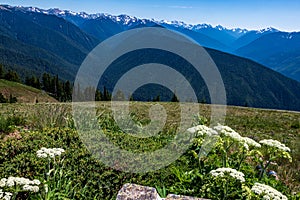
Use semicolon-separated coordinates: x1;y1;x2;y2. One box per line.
99;49;300;110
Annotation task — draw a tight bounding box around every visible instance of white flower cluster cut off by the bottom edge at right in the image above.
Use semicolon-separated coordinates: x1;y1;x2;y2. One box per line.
251;183;288;200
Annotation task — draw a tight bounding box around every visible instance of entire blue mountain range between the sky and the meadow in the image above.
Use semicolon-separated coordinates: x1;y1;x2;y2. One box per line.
0;5;300;110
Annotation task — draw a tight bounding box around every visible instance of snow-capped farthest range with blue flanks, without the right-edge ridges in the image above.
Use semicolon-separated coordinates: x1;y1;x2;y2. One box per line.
3;5;284;52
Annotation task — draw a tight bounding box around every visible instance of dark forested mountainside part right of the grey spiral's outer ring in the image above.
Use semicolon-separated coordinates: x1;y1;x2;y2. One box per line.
208;50;300;110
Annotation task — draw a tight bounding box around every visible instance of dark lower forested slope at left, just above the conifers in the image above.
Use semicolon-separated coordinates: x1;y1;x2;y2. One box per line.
0;34;76;79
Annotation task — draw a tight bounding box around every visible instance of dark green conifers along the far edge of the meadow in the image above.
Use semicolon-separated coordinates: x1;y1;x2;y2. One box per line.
0;64;178;102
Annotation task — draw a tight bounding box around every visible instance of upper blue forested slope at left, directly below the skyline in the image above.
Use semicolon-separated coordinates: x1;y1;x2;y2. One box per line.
0;8;98;64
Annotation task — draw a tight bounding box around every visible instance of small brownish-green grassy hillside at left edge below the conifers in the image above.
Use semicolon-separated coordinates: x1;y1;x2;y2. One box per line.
0;79;57;103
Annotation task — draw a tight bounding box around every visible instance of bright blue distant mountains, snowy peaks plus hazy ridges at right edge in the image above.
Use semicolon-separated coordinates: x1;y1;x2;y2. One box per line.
18;4;300;82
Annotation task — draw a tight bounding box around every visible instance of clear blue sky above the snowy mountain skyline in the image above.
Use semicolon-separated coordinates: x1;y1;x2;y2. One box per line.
0;0;300;31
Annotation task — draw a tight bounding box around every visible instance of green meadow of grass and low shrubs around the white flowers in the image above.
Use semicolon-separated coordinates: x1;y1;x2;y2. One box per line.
0;102;300;199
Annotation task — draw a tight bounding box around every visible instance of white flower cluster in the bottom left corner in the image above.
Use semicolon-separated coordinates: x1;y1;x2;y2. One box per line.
0;176;41;192
